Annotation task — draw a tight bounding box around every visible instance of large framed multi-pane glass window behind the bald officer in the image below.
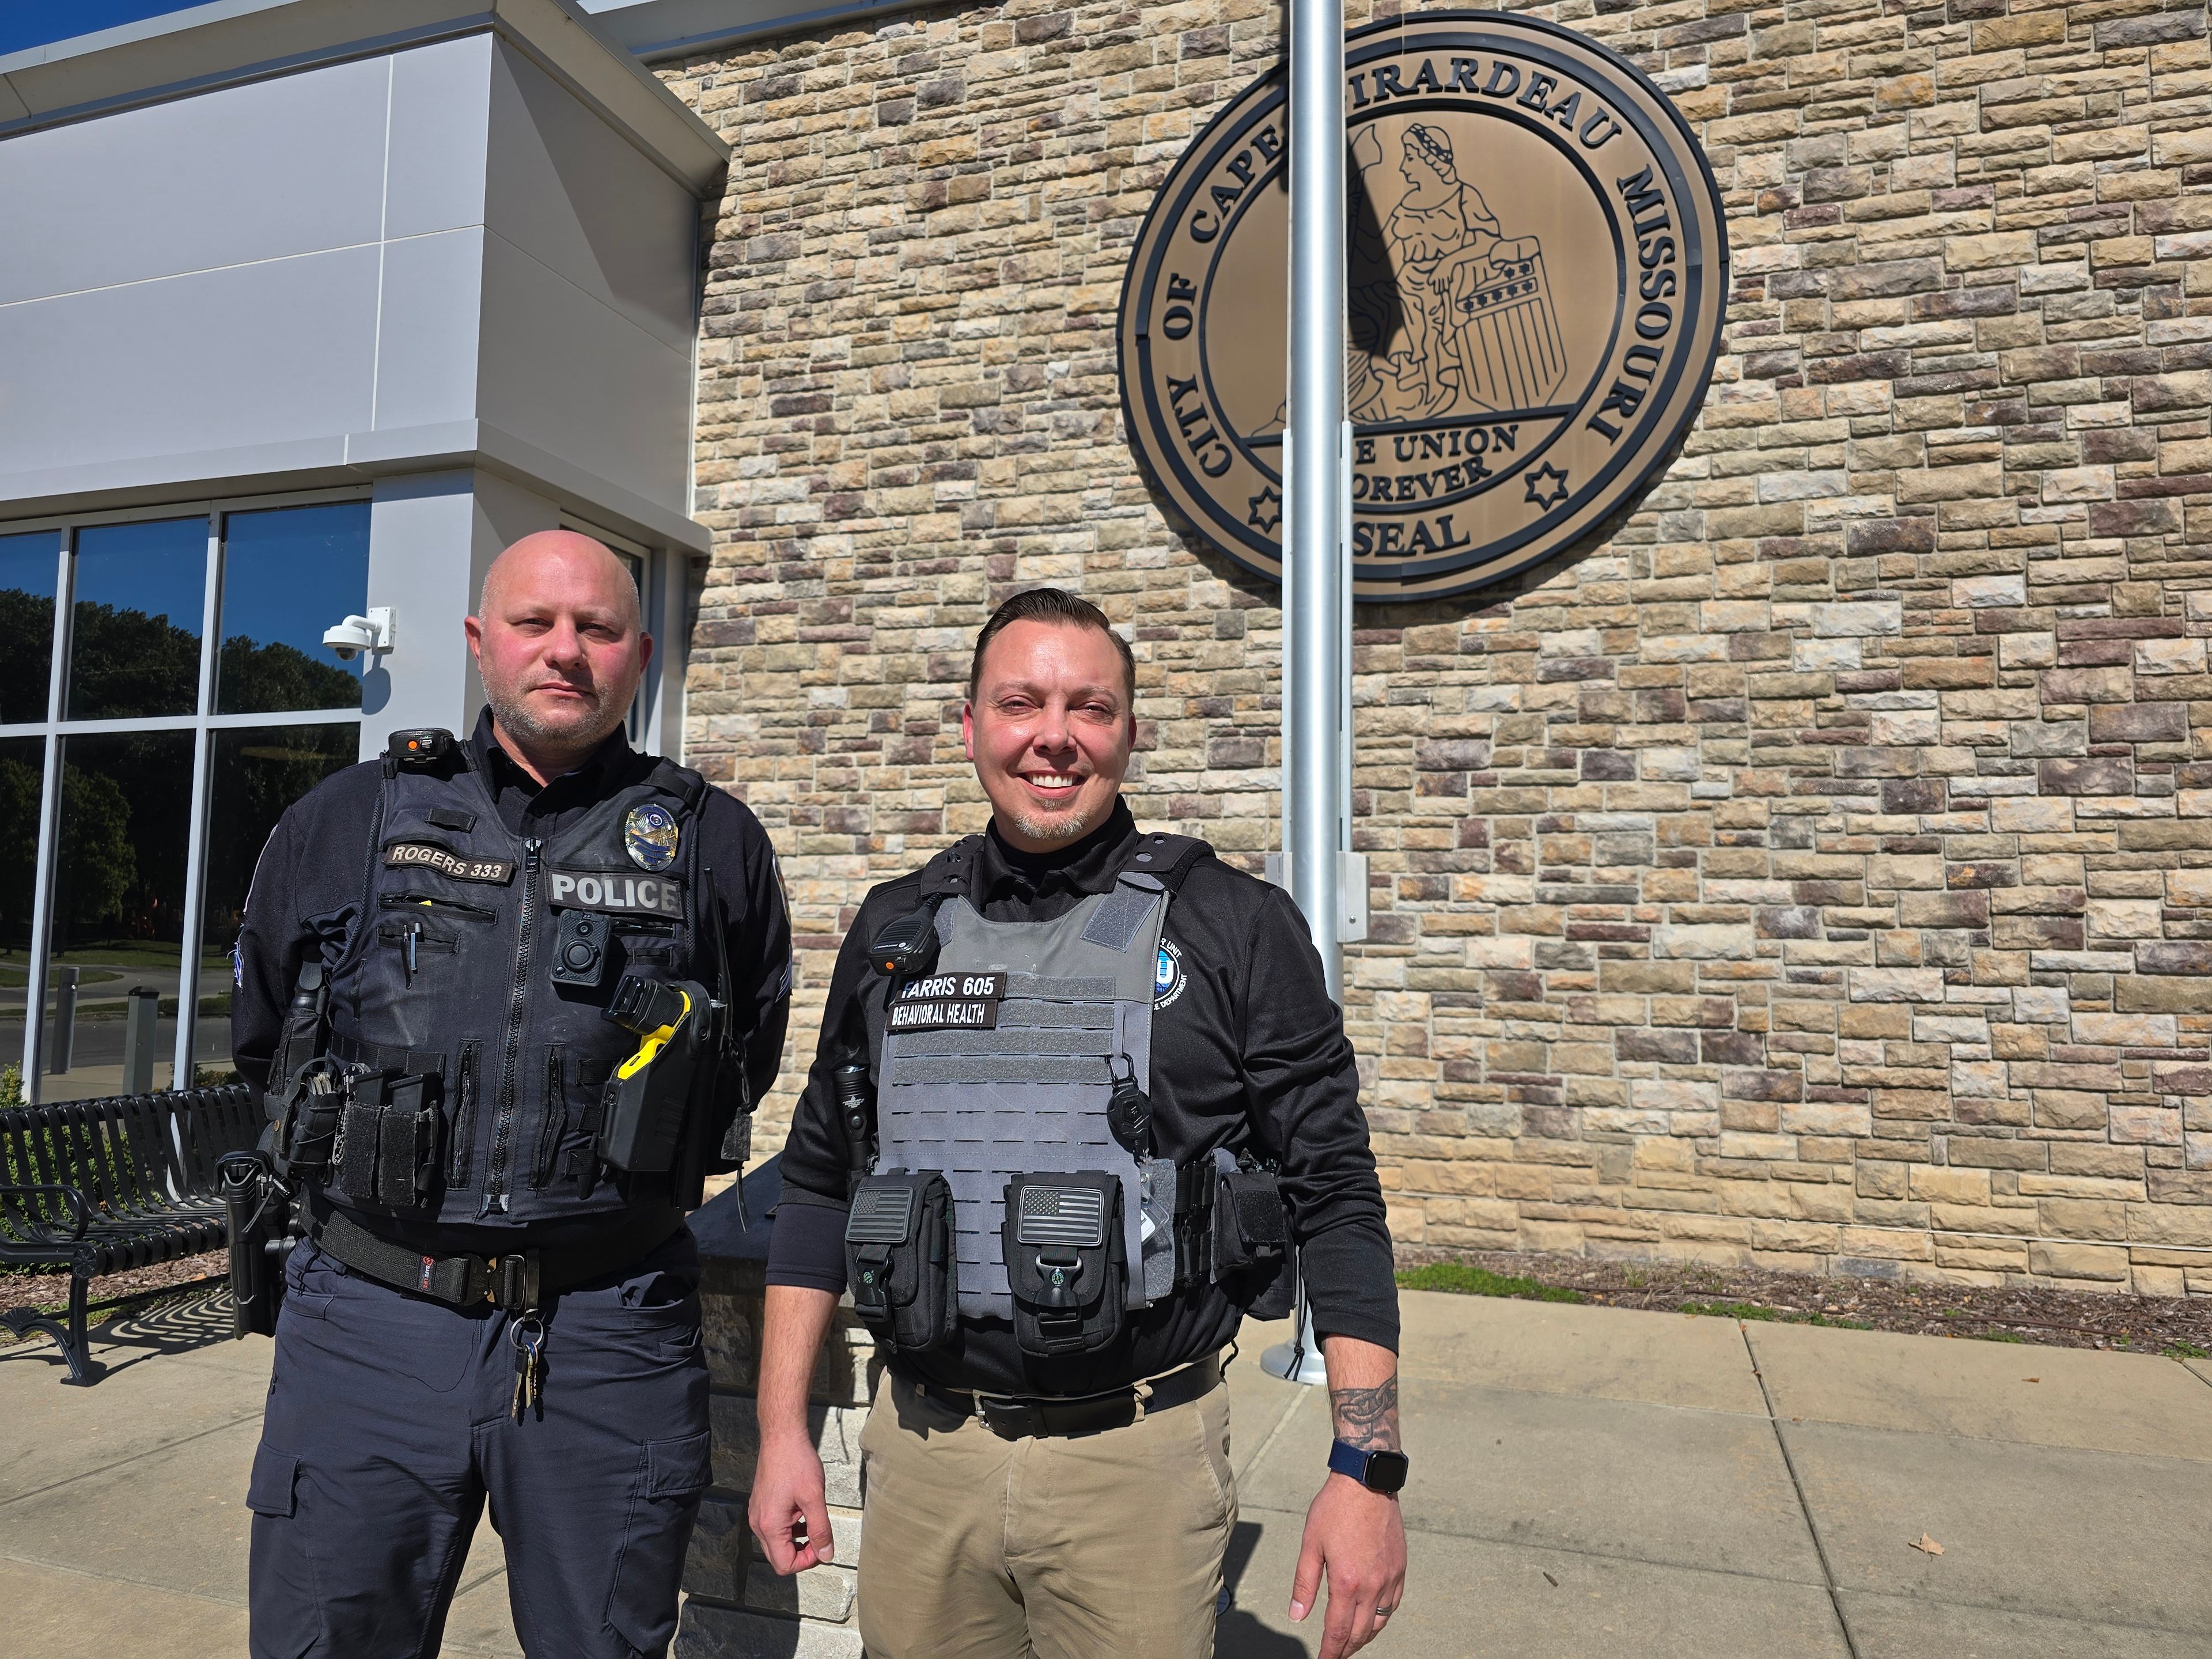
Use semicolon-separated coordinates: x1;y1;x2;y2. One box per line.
0;500;369;1099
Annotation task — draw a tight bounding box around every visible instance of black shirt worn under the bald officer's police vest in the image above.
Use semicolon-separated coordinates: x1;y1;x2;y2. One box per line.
230;710;792;1250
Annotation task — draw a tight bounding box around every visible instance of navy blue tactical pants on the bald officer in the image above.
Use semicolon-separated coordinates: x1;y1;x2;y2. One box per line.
245;1230;708;1659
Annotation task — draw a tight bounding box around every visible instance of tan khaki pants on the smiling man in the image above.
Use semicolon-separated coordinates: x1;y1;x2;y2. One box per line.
861;1372;1237;1659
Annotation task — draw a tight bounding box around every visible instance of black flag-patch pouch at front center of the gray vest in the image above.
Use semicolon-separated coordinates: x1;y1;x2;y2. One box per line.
1000;1170;1128;1358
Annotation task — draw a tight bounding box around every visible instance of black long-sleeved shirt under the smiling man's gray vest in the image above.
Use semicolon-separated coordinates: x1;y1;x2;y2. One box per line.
767;803;1398;1396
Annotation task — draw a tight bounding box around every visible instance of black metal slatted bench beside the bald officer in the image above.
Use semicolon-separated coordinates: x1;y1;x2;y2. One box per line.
0;1084;261;1385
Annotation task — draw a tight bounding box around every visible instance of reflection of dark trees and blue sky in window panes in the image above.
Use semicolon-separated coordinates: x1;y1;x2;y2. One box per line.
0;500;369;1092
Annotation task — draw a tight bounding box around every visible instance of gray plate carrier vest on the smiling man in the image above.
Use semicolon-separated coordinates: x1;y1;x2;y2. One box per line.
876;836;1210;1319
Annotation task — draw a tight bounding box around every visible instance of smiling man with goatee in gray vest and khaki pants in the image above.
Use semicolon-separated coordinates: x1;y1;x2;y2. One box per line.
752;588;1407;1659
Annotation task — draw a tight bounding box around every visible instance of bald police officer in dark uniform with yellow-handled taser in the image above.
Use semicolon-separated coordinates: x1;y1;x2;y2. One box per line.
232;531;790;1659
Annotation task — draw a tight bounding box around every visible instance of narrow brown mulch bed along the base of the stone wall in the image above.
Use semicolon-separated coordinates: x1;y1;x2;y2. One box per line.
1398;1245;2212;1358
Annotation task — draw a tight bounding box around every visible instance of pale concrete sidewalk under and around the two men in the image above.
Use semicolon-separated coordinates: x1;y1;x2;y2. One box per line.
0;1294;2212;1659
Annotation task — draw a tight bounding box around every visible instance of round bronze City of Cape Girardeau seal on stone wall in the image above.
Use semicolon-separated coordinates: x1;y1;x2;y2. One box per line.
1122;11;1728;601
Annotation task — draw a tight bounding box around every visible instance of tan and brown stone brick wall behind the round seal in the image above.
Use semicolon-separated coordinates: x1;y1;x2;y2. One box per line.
664;0;2212;1292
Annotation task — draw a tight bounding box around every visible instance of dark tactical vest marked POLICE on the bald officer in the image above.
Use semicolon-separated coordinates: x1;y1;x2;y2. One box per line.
329;752;712;1225
